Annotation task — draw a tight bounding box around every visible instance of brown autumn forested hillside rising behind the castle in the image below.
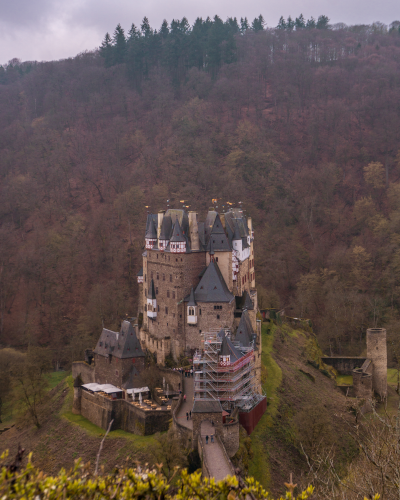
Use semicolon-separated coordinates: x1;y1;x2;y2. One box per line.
0;16;400;366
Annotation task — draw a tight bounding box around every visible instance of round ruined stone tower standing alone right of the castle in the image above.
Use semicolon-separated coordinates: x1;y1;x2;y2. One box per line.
367;328;387;399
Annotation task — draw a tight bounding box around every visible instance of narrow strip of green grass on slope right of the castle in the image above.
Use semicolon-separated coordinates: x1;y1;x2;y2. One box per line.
249;323;282;487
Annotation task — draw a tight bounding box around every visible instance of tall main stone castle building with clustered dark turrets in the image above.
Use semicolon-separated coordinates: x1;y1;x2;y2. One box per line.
138;208;261;390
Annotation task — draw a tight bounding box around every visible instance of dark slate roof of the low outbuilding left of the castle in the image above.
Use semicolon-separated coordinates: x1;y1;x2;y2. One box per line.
94;321;145;359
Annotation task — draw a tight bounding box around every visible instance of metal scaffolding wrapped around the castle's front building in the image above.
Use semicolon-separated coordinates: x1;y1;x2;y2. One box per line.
193;329;264;411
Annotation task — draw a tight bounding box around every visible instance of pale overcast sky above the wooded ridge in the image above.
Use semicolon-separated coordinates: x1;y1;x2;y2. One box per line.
0;0;400;64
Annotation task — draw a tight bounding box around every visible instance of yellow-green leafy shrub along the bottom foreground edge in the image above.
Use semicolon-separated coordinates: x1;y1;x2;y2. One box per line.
0;453;313;500
